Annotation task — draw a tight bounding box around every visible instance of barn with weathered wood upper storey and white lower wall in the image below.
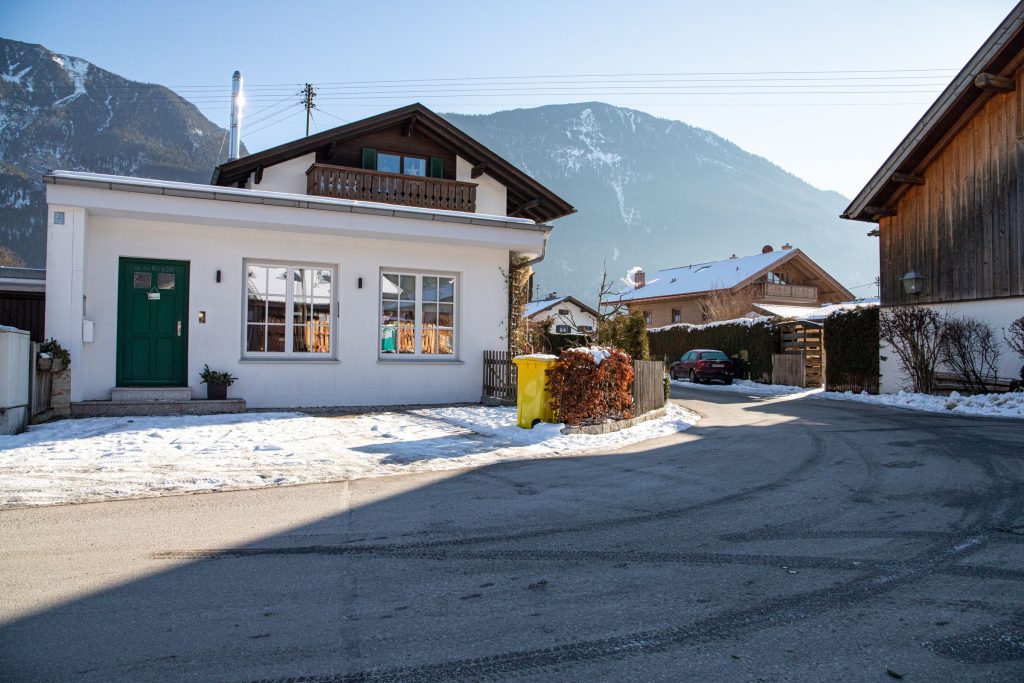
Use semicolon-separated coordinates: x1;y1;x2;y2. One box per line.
843;3;1024;392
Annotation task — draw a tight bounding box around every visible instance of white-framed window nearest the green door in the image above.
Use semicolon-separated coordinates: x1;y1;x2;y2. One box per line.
245;261;335;358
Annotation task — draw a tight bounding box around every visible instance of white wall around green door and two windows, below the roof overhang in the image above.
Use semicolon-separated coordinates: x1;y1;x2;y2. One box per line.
73;217;508;408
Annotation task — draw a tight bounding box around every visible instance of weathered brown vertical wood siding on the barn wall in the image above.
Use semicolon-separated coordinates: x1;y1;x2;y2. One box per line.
879;85;1024;305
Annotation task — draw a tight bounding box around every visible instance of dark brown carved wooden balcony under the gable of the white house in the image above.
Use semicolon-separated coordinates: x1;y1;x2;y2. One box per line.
306;164;476;213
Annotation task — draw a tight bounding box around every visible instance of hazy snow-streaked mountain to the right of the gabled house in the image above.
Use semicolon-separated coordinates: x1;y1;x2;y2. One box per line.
445;102;878;302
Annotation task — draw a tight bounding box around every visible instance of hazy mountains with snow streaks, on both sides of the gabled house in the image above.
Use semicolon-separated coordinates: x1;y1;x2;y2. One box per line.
0;34;878;302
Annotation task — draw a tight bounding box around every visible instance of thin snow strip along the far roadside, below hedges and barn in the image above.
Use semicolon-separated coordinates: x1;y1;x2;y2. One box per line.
673;380;1024;419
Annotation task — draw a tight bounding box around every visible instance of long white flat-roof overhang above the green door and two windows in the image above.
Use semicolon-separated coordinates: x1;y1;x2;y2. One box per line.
43;171;551;257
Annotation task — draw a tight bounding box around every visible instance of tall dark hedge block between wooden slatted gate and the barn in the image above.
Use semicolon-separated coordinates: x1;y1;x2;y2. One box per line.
824;306;879;393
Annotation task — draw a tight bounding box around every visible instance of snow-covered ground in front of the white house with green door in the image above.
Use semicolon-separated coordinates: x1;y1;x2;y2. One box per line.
0;404;698;508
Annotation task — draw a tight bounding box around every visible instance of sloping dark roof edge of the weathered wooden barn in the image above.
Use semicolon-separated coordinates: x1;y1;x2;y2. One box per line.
840;2;1024;222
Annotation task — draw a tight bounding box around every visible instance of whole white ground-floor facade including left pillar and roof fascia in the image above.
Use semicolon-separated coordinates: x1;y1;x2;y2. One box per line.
46;179;544;408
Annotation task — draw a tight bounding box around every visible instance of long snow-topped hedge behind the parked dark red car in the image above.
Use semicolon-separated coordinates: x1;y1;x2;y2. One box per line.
647;319;779;382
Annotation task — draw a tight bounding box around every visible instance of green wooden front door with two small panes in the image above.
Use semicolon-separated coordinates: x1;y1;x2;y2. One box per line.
117;258;188;387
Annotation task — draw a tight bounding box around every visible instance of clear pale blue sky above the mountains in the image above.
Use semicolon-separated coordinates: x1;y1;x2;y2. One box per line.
0;0;1014;197
